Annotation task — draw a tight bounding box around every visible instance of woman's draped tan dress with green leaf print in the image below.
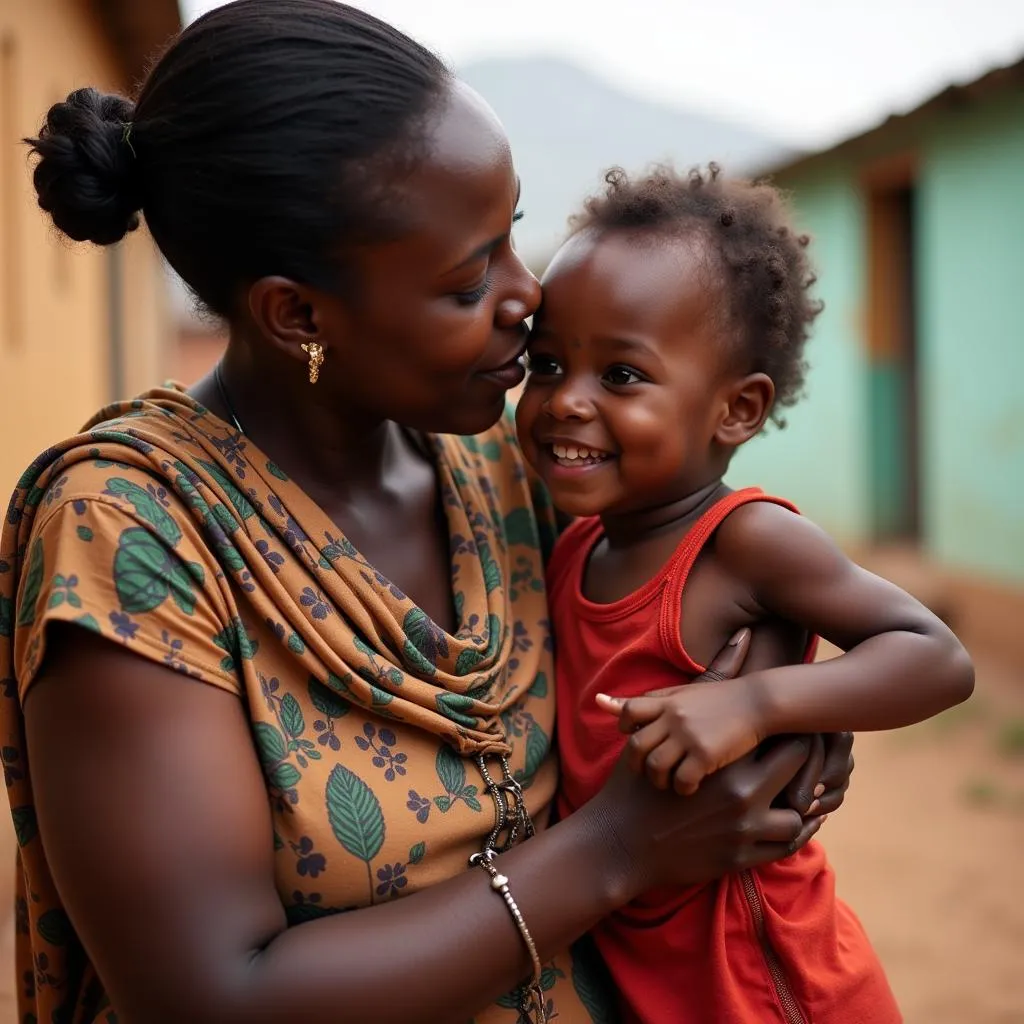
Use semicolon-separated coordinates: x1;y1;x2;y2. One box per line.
0;387;610;1024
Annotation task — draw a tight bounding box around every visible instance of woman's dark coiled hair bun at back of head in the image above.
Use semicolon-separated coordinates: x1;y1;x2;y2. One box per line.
26;89;142;246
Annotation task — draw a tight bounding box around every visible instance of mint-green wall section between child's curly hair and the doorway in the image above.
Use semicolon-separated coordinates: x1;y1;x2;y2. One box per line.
729;165;868;541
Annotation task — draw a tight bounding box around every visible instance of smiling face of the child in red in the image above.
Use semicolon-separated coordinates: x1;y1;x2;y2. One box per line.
517;231;738;515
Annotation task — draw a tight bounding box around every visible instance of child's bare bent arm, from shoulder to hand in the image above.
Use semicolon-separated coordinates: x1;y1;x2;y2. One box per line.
601;503;974;793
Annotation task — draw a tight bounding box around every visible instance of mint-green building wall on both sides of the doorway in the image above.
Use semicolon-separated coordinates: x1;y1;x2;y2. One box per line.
730;86;1024;584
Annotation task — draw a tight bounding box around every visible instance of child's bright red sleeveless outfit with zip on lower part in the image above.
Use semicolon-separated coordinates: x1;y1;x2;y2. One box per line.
548;488;901;1024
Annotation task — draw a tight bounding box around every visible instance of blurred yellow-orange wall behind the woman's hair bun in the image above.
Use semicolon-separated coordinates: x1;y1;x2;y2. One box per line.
0;0;171;495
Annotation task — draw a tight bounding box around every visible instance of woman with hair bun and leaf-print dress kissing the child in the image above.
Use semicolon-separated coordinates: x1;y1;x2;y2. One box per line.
0;0;849;1024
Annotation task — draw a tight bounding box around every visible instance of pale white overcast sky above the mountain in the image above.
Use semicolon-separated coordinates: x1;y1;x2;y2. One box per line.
180;0;1024;146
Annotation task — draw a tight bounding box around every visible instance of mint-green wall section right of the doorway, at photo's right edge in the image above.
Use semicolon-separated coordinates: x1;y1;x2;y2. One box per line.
919;94;1024;581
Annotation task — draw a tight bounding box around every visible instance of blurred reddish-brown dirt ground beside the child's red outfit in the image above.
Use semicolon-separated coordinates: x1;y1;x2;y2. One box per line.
0;598;1024;1024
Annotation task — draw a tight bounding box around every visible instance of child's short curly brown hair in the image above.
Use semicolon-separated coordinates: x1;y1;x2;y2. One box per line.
571;164;822;427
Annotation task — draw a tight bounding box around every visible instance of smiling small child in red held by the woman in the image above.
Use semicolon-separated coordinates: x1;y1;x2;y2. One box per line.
518;165;974;1024
